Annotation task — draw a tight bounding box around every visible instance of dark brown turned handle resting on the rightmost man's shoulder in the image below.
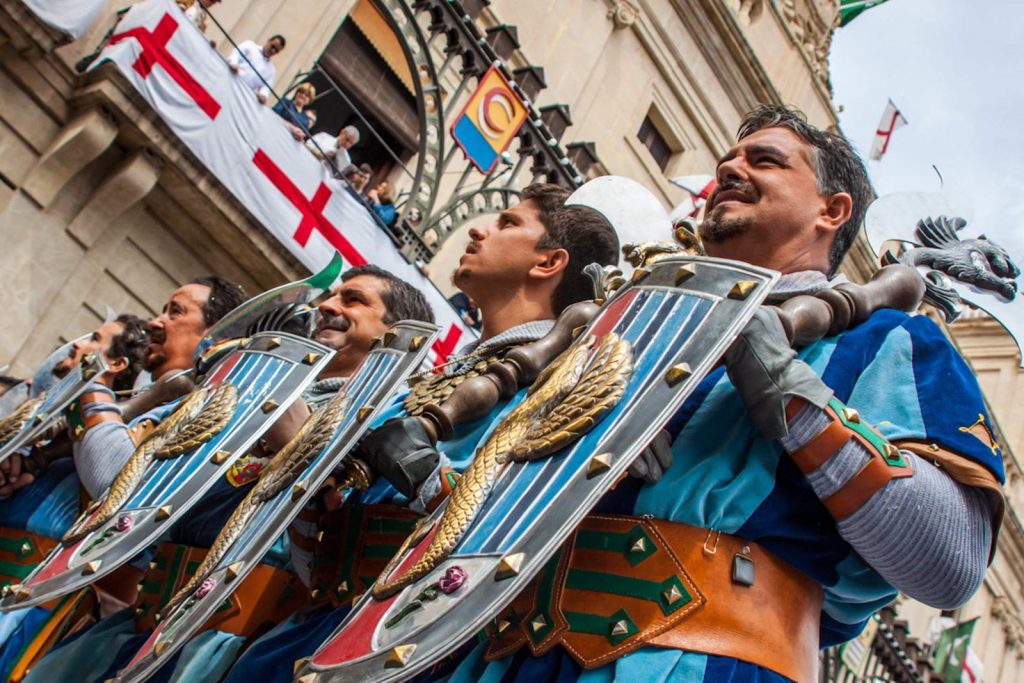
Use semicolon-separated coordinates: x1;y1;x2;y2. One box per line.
776;264;925;348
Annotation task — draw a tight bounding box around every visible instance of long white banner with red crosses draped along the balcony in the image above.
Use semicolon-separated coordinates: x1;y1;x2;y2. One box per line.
94;0;476;360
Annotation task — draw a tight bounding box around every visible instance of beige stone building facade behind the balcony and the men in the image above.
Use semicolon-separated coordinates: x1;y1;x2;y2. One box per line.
0;0;1024;681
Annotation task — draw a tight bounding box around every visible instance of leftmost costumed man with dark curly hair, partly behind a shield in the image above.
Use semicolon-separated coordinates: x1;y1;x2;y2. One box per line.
0;314;146;680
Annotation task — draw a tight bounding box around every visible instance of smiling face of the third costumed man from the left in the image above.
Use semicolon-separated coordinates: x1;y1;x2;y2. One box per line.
313;275;390;376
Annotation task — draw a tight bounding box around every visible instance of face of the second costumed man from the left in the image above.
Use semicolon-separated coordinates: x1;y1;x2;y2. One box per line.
142;285;210;379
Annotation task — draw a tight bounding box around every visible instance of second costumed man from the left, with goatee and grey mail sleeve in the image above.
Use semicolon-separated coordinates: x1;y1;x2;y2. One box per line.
12;275;246;680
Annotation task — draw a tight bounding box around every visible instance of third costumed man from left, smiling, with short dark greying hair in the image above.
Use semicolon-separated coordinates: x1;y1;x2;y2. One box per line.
19;265;433;681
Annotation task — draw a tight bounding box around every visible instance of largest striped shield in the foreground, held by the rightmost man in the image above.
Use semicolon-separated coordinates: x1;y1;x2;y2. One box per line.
296;256;777;683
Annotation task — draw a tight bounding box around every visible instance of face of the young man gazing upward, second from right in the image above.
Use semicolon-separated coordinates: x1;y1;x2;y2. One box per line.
452;200;547;299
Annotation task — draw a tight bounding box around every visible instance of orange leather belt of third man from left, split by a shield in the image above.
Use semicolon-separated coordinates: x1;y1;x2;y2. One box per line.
134;543;306;638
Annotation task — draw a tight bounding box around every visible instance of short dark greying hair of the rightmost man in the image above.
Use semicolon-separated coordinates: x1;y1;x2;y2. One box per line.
736;104;871;276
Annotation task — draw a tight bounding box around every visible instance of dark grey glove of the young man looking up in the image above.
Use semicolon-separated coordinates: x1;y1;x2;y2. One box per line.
355;417;441;498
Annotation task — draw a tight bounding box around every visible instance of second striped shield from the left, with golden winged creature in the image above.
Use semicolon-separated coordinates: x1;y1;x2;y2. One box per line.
0;333;333;611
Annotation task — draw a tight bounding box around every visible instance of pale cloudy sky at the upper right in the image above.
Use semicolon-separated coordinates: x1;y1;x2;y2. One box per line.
829;0;1024;255
